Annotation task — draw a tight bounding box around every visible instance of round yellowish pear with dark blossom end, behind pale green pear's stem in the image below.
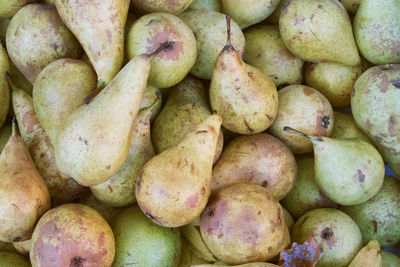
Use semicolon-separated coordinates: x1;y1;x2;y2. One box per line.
268;85;334;154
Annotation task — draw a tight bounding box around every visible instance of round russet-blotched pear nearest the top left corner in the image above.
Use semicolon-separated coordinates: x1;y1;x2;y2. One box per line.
6;4;82;83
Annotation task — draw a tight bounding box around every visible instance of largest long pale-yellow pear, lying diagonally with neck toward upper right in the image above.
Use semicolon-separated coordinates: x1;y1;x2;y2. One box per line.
54;55;150;186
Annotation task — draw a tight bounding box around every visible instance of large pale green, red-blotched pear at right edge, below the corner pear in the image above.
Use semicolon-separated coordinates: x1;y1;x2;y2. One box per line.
351;64;400;176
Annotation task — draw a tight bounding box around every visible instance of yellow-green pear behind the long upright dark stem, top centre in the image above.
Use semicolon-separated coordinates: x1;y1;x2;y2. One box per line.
179;10;245;80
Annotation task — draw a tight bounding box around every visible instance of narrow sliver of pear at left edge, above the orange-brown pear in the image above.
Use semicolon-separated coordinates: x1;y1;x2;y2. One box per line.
0;42;10;127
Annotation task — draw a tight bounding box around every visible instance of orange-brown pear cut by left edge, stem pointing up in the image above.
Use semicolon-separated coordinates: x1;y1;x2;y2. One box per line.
0;121;50;242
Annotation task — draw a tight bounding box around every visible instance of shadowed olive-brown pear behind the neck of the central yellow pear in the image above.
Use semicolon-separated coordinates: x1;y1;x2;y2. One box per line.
151;76;223;162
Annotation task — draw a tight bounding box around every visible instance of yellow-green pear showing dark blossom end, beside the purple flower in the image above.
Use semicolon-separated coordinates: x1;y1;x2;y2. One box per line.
292;208;362;267
